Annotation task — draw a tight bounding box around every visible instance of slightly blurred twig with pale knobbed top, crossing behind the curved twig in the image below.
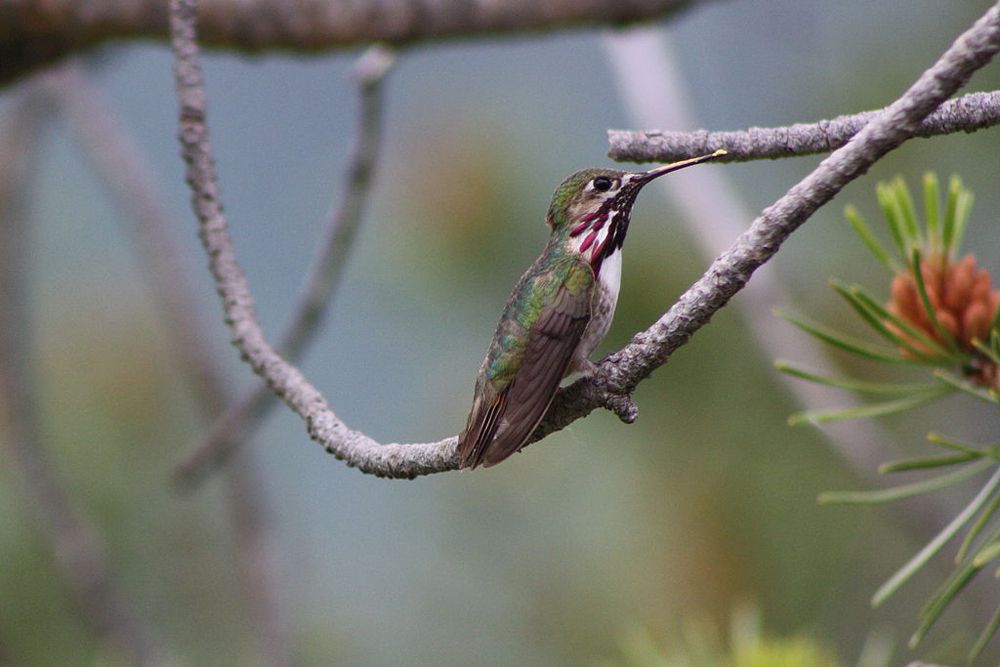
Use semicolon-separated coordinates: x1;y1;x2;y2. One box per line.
175;47;392;484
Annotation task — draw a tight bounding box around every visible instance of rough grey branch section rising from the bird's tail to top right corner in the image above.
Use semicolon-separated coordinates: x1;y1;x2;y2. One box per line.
548;2;1000;435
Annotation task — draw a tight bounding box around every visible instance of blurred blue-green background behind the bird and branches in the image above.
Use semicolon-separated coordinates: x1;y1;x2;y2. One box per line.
0;0;1000;665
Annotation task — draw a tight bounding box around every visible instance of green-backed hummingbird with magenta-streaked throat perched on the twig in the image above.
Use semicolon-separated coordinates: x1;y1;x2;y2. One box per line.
458;150;726;468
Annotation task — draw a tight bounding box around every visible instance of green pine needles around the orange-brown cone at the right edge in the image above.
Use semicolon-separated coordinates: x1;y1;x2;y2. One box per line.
775;173;1000;662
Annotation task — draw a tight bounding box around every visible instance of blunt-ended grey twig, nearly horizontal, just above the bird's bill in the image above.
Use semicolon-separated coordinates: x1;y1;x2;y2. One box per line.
608;90;1000;162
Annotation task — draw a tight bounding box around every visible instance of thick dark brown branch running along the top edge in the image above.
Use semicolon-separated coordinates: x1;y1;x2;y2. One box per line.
0;0;697;86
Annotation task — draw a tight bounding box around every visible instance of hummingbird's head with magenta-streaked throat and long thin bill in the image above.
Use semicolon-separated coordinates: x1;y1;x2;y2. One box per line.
546;150;726;271
